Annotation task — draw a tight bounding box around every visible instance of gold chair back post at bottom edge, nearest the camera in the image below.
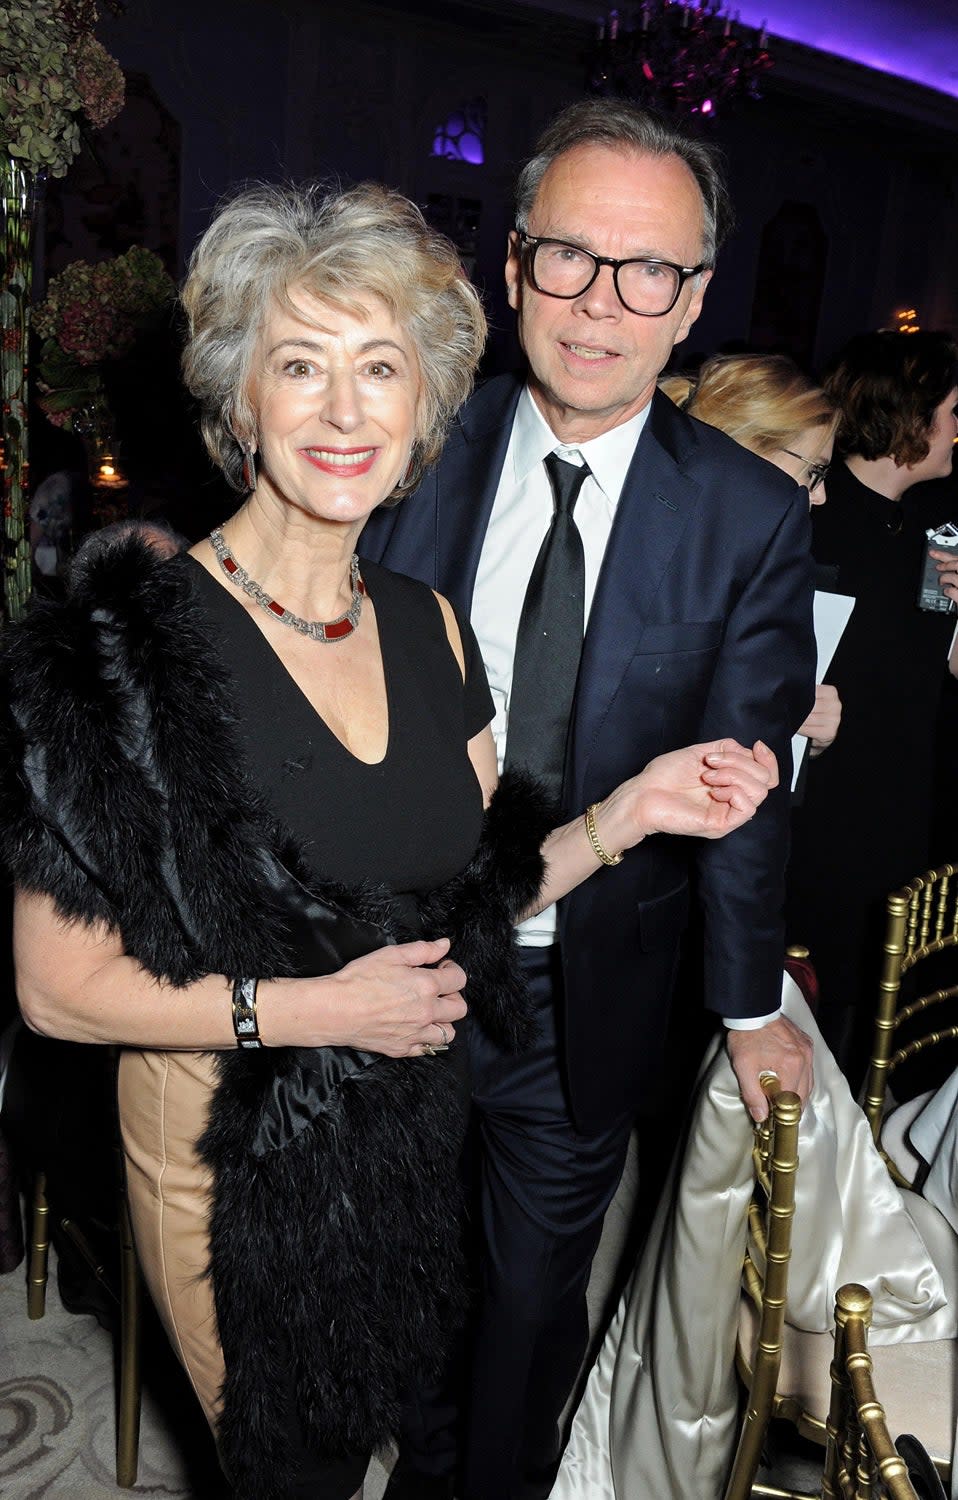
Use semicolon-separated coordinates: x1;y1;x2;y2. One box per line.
822;1283;919;1500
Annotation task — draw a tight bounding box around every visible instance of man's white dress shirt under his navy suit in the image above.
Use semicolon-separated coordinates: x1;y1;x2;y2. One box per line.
471;386;778;1029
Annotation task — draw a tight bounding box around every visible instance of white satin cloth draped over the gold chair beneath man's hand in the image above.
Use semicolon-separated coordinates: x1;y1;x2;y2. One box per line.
550;975;958;1500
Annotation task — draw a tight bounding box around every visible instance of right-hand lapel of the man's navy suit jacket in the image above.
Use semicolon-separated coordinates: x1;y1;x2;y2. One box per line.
567;392;700;806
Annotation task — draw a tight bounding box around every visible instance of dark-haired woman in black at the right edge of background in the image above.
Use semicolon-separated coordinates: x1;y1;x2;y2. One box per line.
789;333;958;1085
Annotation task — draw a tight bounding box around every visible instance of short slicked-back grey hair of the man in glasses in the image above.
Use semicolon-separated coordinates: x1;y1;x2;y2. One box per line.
516;99;733;266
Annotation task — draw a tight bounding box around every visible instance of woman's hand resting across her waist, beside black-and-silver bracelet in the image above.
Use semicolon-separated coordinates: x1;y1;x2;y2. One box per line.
269;938;466;1058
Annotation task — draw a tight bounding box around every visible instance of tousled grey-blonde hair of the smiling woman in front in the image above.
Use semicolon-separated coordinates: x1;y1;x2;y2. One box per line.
181;183;486;498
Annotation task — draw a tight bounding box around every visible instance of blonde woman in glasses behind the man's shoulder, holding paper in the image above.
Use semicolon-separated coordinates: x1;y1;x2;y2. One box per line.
660;354;841;758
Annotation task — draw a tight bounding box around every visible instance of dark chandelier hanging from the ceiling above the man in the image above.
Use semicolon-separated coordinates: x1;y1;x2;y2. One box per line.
588;0;772;120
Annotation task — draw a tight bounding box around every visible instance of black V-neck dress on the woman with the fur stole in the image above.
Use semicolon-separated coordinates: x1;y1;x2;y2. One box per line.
163;558;493;1500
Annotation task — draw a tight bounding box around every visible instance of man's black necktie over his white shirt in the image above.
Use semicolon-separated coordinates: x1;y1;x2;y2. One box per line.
505;453;589;801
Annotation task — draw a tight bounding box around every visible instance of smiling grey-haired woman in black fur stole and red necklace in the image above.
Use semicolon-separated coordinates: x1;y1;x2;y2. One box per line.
3;185;774;1500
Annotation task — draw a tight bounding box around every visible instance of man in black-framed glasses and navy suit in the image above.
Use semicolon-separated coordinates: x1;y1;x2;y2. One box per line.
363;101;814;1500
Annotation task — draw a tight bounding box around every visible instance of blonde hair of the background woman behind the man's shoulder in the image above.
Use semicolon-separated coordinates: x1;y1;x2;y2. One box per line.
660;354;838;458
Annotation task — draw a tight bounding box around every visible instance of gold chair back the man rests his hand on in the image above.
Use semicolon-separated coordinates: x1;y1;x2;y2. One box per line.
724;1074;802;1500
